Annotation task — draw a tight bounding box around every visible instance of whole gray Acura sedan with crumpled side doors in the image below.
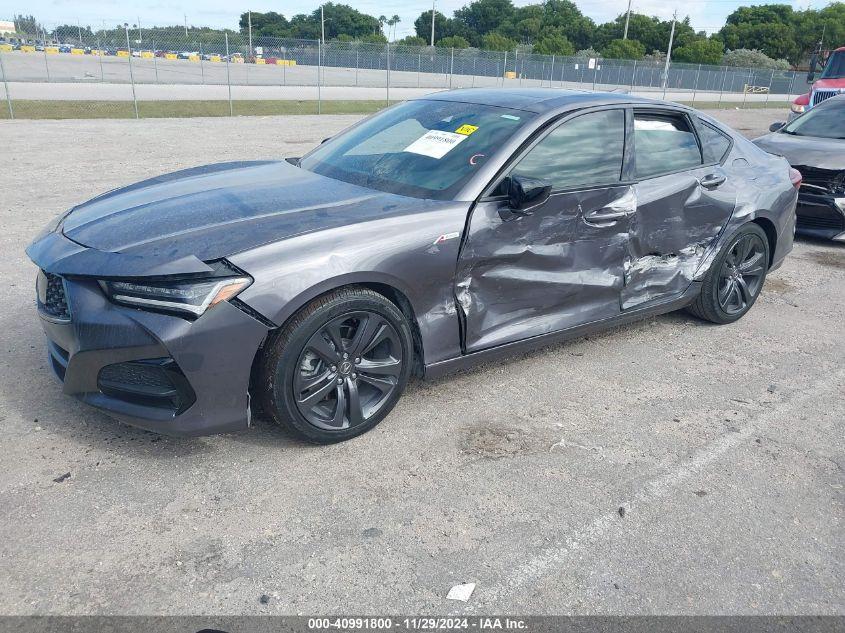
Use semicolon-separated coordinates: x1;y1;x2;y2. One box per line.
27;89;800;442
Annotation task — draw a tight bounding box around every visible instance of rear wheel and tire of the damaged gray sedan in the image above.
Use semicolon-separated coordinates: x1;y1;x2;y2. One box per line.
687;222;770;324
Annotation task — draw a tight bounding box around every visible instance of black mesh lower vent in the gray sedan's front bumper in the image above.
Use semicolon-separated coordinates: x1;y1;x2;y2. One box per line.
97;358;196;413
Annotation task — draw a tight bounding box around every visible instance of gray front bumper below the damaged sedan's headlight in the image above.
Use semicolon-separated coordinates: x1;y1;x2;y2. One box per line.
34;276;268;436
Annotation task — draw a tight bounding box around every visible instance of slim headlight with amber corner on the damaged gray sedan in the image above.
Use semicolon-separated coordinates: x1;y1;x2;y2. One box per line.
100;263;252;316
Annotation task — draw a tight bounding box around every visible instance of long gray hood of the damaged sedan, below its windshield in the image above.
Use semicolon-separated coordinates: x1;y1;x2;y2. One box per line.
27;161;443;275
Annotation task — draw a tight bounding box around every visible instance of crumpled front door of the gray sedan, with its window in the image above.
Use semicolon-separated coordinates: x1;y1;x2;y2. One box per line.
455;108;635;352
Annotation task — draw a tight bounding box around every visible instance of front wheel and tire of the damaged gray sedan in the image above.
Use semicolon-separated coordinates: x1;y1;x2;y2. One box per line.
259;286;414;444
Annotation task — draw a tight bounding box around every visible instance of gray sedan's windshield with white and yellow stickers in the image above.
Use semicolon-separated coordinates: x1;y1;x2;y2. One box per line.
300;100;534;200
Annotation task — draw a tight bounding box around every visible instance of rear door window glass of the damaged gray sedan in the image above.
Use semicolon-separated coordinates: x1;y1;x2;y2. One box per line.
634;112;702;178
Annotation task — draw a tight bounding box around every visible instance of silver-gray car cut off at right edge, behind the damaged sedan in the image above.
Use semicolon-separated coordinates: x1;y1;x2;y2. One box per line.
754;95;845;242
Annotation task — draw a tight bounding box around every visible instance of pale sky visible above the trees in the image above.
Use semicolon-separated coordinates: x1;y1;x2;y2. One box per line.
8;0;816;38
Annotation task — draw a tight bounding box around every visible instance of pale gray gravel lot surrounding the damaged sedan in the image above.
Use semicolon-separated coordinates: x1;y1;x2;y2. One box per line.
0;111;845;614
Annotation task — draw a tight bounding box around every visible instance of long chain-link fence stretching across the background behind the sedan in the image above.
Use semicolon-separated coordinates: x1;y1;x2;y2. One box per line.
0;28;806;118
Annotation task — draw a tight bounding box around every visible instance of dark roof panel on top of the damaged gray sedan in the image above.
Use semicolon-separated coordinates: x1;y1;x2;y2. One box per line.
419;88;678;114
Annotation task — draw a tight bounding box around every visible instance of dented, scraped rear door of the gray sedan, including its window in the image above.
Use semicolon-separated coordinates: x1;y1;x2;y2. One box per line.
621;108;736;311
